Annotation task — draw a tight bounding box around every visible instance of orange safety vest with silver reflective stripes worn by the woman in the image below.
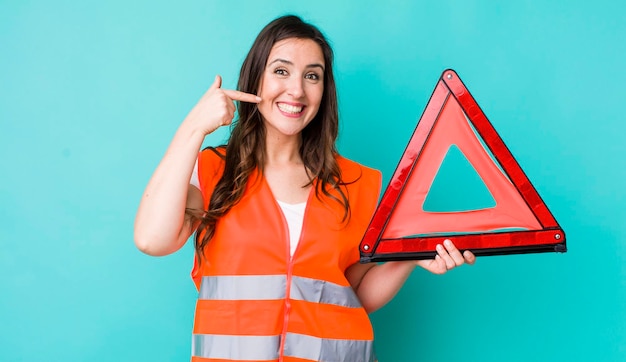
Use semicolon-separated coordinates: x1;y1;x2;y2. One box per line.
191;149;381;362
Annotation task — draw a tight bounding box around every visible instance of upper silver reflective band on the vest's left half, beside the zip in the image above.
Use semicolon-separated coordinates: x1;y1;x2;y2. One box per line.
198;275;287;300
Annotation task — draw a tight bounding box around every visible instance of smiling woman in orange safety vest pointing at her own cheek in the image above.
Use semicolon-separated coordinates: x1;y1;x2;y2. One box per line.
135;16;475;362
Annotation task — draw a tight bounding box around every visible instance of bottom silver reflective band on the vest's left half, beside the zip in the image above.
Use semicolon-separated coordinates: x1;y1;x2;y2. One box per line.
191;334;280;361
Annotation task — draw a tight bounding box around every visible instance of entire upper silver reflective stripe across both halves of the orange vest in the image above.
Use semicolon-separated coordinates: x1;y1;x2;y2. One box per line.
199;275;361;308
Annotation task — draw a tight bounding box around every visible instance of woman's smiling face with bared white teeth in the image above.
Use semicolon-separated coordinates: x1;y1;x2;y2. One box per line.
258;38;326;139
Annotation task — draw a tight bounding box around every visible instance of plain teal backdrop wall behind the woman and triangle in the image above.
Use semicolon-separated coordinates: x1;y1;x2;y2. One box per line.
0;0;626;362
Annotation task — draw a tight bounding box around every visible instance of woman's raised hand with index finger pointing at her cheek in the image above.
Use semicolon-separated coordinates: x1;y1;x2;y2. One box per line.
185;75;261;135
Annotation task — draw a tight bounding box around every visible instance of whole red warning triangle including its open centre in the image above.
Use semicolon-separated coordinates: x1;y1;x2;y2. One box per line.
360;69;567;263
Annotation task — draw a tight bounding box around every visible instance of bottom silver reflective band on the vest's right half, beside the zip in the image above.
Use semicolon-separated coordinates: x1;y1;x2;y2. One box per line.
285;333;374;362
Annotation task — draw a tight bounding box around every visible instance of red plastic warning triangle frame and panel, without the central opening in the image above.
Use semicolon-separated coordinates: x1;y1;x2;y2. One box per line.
359;69;567;263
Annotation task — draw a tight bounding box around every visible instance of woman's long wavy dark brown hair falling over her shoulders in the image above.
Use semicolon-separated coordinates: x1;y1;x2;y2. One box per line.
195;15;350;262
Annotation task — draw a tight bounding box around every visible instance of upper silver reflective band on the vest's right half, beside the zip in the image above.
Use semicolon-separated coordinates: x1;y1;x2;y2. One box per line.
289;276;361;308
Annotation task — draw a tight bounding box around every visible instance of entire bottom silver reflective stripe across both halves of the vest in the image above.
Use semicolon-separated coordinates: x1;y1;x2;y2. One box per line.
191;333;374;362
